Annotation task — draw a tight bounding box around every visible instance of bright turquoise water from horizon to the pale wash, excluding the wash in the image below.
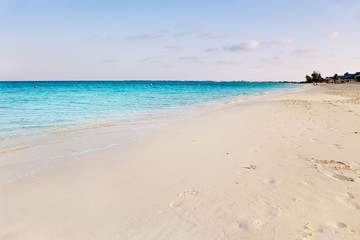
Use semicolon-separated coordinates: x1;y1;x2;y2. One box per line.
0;81;297;147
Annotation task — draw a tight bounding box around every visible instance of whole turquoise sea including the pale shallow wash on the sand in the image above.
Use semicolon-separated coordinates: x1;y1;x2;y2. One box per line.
0;81;299;185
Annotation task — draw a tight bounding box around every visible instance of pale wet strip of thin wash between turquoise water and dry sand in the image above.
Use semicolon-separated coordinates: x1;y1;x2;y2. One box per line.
0;86;306;186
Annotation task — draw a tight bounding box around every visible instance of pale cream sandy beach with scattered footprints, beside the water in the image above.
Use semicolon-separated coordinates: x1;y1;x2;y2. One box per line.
0;83;360;240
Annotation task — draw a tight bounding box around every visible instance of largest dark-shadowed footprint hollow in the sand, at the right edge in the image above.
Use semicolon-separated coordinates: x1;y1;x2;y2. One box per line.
312;158;360;182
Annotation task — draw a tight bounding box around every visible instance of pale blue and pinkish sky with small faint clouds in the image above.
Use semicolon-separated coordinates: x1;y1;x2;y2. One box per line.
0;0;360;81
